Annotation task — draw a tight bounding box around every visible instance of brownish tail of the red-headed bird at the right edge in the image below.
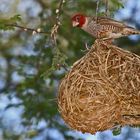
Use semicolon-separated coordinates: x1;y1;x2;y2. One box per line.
123;27;140;35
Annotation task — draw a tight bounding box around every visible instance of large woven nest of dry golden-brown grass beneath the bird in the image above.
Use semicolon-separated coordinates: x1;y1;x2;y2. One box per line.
58;40;140;134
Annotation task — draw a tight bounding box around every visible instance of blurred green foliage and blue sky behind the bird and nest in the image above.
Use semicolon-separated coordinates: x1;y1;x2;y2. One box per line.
0;0;140;140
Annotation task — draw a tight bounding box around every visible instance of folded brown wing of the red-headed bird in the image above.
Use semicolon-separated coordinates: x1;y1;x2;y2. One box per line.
93;17;126;28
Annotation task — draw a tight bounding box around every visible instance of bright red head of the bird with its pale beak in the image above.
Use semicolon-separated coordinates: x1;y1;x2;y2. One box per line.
71;14;86;27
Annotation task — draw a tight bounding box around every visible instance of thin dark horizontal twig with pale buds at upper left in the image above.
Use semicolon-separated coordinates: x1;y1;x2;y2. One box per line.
6;24;50;34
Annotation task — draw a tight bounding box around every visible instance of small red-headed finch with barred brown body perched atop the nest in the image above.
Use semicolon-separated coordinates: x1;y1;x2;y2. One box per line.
72;14;140;40
